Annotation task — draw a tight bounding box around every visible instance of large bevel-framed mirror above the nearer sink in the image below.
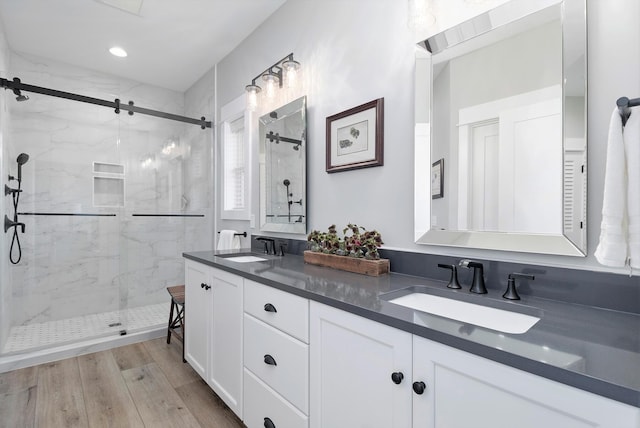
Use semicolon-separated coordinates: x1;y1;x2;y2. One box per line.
414;0;587;256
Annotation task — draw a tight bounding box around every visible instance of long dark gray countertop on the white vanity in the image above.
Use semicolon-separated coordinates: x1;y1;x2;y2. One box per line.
183;249;640;408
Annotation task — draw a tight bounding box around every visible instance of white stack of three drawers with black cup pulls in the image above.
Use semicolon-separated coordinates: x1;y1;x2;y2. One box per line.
243;280;309;428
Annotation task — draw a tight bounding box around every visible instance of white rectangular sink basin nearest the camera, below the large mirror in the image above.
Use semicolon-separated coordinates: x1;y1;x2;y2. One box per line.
389;292;540;334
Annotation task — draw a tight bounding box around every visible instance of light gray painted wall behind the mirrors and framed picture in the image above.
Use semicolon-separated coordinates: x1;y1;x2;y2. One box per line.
216;0;640;274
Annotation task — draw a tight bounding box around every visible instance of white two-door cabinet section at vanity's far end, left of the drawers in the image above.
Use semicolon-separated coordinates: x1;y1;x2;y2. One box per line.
185;260;243;417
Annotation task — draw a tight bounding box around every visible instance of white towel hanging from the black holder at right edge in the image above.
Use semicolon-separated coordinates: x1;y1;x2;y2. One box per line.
595;108;640;268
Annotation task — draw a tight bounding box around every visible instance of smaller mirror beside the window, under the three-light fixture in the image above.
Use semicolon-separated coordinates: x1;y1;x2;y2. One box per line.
258;97;307;234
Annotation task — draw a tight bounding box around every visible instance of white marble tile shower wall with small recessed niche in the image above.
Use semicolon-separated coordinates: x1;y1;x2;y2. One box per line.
5;54;212;325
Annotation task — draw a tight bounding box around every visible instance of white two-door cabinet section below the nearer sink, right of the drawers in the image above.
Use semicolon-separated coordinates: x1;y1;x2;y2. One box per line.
310;302;640;428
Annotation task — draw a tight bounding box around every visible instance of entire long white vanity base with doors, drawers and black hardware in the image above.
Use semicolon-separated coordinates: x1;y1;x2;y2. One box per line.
185;260;640;428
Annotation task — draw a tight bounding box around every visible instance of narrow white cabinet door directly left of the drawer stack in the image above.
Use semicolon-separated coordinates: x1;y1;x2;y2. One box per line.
207;268;243;418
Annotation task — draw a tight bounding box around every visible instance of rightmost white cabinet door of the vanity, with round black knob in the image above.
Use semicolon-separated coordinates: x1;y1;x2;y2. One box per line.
413;337;640;428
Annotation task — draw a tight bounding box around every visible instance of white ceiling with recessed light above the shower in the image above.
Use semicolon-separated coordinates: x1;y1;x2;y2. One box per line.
0;0;286;92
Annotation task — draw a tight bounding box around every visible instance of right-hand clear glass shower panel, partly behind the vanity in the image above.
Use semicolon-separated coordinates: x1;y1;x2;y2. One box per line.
119;109;212;333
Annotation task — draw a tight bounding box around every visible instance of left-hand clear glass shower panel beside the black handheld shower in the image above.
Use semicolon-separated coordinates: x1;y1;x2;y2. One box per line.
2;94;126;354
